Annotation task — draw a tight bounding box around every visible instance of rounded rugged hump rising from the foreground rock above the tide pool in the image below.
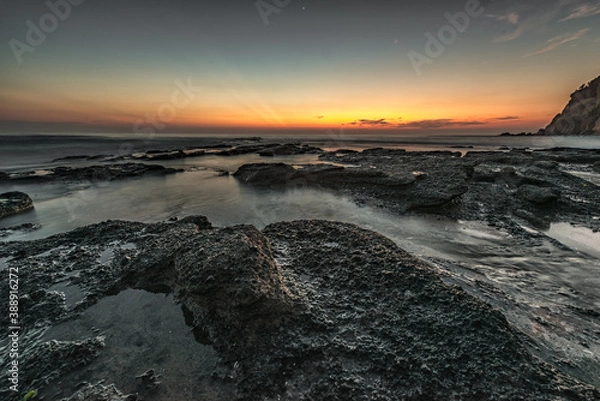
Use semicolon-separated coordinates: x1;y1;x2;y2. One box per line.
173;226;291;327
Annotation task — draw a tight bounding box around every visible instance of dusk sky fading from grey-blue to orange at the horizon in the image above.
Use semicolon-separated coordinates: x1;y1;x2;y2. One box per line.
0;0;600;135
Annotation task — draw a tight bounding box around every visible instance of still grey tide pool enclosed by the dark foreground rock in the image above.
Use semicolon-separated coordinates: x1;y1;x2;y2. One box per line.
40;290;233;401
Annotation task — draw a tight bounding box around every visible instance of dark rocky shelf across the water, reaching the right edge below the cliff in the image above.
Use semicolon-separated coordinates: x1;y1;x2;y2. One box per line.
234;148;600;231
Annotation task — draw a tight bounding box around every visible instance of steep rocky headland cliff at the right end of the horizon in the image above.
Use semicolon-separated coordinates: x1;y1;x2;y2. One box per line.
539;77;600;135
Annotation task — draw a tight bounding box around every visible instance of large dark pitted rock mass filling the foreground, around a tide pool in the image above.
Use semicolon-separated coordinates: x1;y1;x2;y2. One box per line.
0;216;600;401
